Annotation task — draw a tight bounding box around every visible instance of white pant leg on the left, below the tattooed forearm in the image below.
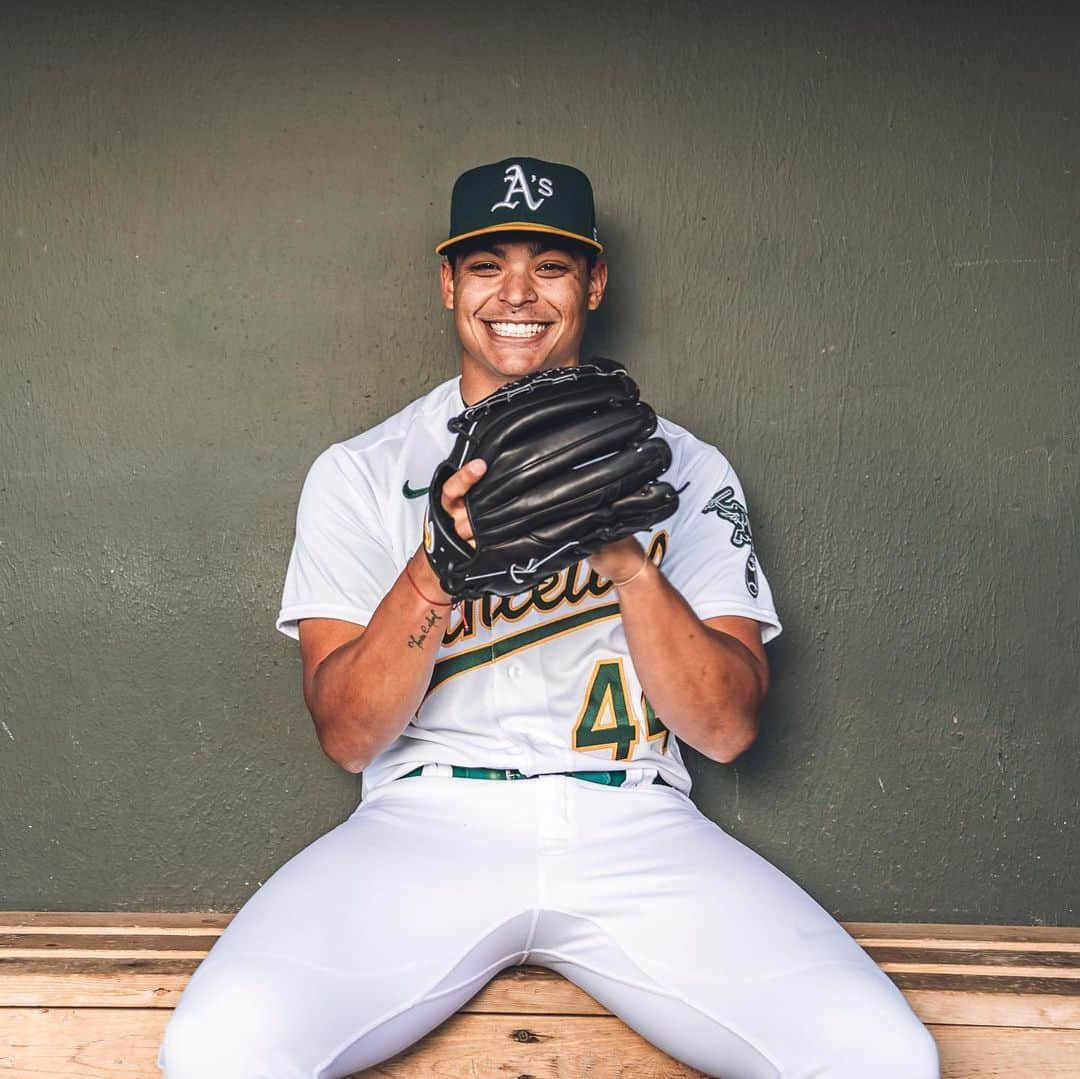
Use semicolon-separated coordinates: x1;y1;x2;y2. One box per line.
158;777;536;1079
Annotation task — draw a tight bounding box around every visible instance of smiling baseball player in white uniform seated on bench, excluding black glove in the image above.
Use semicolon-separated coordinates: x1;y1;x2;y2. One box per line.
158;158;939;1079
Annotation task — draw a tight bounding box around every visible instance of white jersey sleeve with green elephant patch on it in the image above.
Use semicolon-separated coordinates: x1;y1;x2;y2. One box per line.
663;446;782;644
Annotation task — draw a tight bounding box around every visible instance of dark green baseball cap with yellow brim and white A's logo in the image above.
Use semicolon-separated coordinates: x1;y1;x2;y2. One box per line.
435;158;604;255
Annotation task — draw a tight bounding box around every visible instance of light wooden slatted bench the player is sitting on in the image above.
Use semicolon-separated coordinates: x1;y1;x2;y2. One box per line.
0;912;1080;1079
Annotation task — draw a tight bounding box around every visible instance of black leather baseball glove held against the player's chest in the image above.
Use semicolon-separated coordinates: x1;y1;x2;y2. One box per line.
424;361;678;599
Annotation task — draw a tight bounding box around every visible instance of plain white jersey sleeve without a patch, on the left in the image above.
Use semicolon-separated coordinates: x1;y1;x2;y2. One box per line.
276;445;400;639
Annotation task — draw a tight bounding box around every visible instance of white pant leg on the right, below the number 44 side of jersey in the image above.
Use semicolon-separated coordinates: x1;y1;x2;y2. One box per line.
527;780;940;1079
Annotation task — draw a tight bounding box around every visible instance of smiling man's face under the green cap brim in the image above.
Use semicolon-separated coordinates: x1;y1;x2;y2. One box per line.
441;233;607;392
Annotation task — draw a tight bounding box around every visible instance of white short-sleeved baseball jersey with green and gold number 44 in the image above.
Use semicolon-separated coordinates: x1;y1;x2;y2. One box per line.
276;376;781;798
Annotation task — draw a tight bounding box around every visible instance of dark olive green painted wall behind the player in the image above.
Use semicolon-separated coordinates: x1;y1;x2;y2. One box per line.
0;0;1080;923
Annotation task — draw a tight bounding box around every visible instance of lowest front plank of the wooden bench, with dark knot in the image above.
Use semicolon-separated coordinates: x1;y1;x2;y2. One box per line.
6;1008;1080;1079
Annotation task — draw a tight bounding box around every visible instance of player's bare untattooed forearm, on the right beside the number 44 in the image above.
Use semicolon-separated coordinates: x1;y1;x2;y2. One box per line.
591;541;762;763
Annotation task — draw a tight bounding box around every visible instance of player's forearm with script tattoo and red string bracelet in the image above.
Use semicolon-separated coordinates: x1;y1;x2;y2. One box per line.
308;551;450;772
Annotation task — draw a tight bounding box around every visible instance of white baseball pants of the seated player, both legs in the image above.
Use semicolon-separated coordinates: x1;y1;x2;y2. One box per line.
158;770;939;1079
